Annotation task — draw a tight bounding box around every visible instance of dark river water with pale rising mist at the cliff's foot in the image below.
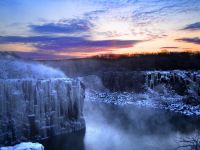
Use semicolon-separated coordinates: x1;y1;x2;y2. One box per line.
45;102;200;150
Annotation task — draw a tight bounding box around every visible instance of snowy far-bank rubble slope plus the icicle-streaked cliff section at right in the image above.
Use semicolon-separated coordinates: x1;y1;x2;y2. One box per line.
86;70;200;116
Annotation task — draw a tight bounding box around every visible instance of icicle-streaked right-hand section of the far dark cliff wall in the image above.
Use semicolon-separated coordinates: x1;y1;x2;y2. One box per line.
146;70;200;96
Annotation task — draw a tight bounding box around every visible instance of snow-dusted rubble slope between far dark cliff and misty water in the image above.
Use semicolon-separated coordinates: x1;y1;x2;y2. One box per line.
86;90;200;117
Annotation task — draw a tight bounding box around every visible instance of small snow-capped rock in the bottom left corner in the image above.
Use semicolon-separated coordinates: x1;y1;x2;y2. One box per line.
0;142;44;150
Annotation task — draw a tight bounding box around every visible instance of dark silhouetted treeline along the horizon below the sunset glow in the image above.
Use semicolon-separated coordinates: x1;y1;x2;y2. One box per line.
42;52;200;76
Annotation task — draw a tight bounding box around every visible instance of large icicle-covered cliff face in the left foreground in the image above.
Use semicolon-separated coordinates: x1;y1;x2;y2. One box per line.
0;78;85;145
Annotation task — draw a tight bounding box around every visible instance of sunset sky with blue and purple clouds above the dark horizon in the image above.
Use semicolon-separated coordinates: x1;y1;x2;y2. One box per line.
0;0;200;59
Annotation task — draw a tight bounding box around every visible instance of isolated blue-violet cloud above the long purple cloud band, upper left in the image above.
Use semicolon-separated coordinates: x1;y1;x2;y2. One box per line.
29;19;92;33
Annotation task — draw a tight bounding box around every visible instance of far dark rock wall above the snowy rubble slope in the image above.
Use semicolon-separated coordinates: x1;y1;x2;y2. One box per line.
101;70;200;96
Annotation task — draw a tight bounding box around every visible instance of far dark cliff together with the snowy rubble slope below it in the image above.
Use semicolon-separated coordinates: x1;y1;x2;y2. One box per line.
85;70;200;116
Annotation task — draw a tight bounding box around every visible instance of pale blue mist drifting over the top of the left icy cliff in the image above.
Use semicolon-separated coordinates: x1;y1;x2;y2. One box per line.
0;56;66;79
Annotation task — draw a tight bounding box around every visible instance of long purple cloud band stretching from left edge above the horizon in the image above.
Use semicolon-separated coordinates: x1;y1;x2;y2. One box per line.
0;36;142;51
